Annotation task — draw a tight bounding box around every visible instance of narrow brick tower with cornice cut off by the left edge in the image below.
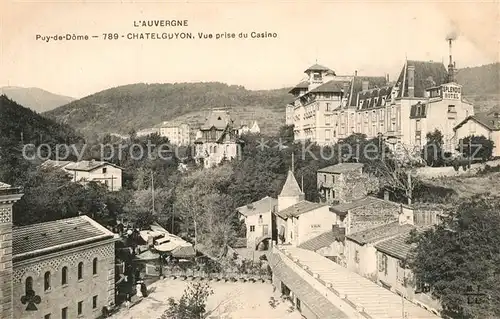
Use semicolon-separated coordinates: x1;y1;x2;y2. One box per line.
0;182;22;319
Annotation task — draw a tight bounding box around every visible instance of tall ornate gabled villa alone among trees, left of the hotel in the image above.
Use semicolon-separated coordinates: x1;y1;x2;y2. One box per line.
195;110;242;168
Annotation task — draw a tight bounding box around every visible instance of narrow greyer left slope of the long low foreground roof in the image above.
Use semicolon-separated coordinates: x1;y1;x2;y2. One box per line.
269;253;349;319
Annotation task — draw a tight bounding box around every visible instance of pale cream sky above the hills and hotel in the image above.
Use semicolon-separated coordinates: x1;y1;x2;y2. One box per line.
0;0;500;98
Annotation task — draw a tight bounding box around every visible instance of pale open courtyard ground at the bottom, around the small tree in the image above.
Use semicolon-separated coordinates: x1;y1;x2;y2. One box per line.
111;279;302;319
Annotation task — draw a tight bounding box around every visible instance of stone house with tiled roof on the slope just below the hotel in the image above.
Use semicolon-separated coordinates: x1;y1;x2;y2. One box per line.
317;163;378;205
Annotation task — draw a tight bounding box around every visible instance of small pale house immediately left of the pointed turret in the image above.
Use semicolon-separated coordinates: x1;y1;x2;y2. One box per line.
237;196;278;249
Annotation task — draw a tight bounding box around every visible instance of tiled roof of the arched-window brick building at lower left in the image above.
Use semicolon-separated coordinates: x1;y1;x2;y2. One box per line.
12;216;114;258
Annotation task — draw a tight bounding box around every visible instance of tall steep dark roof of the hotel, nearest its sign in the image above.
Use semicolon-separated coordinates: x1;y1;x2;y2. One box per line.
396;61;448;97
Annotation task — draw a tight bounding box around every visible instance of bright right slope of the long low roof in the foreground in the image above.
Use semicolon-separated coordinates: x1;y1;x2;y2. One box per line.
278;247;439;319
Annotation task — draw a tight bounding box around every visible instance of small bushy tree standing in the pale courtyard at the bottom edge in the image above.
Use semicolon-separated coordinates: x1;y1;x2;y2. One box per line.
161;282;213;319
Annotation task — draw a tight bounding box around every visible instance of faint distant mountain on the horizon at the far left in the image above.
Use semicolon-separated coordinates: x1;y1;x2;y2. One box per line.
0;86;75;113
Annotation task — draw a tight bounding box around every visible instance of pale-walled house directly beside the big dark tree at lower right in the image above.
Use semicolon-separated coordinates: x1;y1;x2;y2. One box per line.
374;233;441;313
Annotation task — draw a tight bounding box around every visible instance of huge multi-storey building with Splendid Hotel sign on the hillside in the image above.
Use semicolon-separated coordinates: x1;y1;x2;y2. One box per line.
286;55;474;150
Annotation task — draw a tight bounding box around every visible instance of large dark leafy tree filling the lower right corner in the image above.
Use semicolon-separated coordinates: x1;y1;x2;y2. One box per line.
409;195;500;319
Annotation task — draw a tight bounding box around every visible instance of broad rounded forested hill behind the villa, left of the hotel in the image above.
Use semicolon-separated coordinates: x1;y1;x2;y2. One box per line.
44;82;290;134
